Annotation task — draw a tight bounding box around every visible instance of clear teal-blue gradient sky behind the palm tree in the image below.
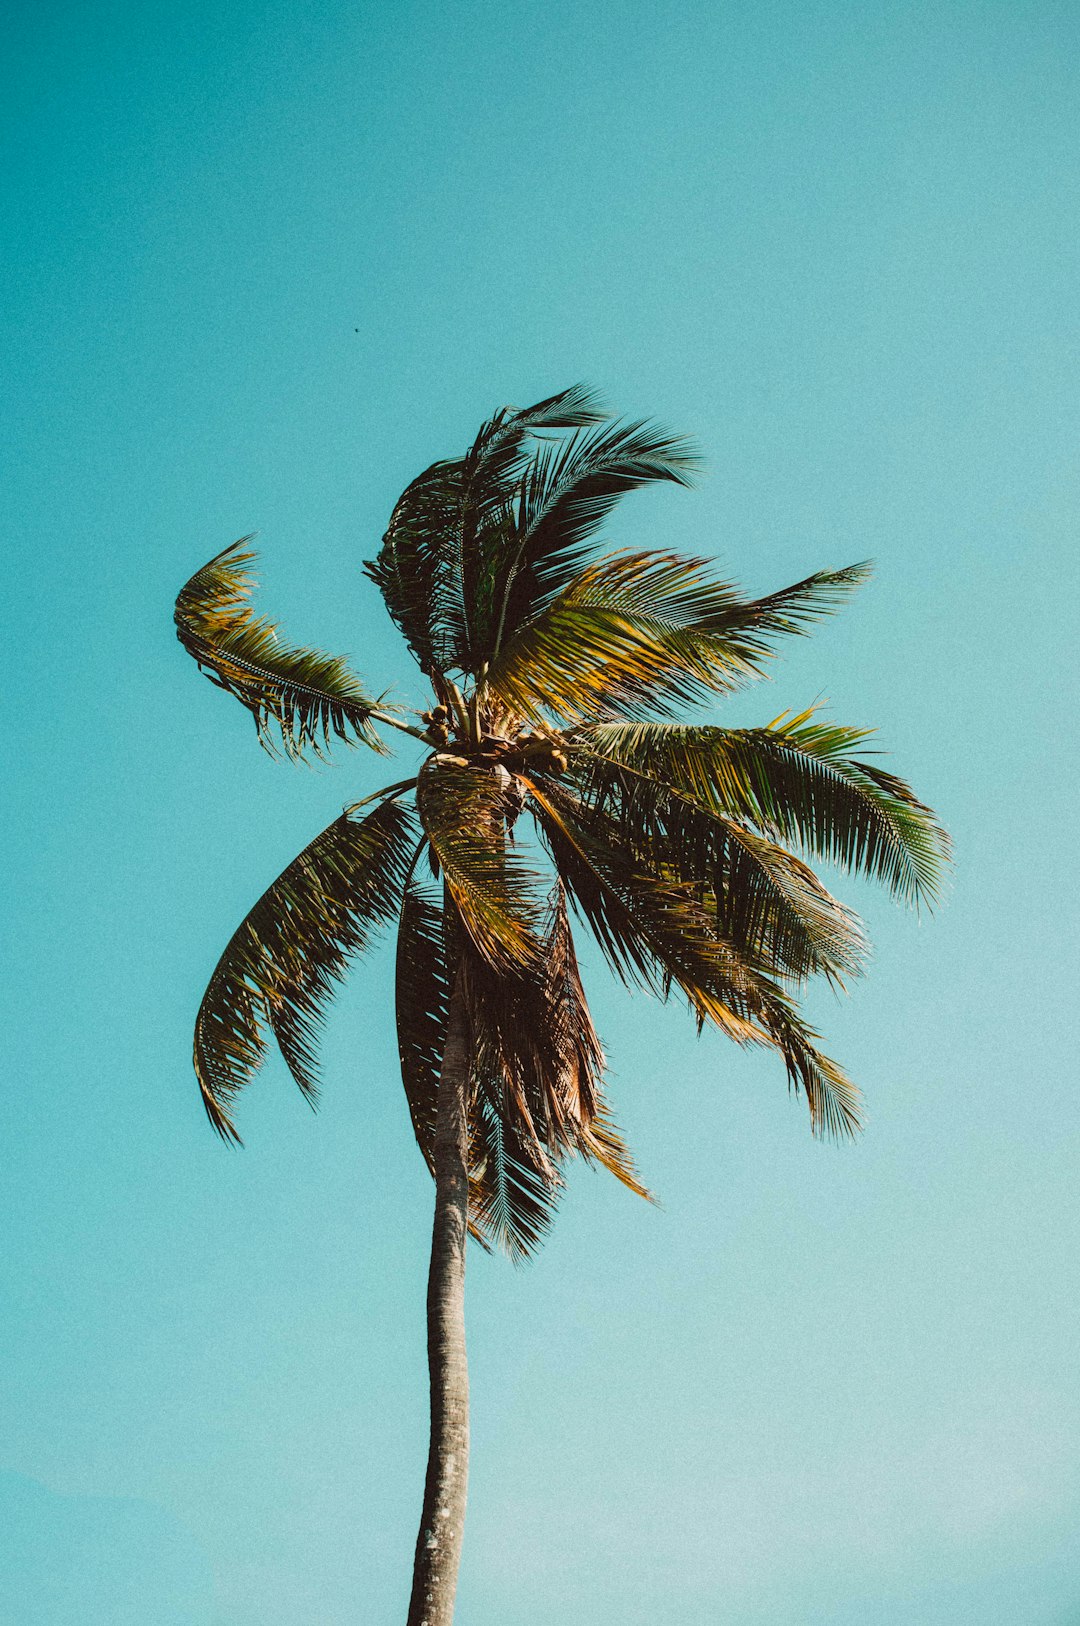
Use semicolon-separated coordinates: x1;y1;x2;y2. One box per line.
0;0;1080;1626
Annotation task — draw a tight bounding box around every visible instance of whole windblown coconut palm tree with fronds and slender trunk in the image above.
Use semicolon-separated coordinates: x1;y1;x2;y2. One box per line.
176;387;947;1626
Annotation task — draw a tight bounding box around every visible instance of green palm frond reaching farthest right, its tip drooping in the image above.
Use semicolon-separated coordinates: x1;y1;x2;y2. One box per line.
579;714;950;906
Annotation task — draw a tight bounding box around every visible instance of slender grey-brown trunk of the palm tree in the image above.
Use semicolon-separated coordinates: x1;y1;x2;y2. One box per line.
408;985;470;1626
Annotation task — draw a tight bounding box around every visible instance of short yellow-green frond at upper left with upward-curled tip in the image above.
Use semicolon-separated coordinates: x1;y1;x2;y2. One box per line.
176;537;385;758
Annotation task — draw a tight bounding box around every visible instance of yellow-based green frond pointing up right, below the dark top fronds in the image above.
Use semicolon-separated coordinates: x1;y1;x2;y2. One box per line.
485;553;865;725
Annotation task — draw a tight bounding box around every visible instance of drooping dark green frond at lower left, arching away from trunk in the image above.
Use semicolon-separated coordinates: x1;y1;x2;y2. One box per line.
195;780;418;1141
